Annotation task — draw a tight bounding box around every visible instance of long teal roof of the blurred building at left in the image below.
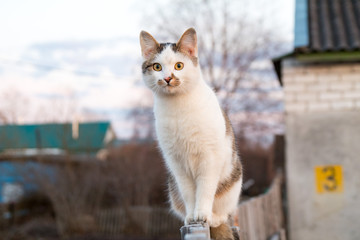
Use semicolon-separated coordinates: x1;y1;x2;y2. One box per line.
0;122;110;152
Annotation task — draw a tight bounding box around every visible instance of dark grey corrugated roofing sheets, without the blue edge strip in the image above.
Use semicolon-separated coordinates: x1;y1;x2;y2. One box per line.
304;0;360;52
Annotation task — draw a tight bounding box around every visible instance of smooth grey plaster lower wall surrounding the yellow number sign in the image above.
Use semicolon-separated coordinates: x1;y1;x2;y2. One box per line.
286;111;360;240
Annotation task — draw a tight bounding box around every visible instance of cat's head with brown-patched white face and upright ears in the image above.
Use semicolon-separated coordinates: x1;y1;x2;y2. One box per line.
140;28;200;95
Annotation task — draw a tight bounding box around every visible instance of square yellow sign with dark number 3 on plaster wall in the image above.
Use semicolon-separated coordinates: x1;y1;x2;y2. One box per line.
315;165;344;193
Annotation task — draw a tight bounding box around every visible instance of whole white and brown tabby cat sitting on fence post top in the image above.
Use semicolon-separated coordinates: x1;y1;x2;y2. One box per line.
140;28;242;240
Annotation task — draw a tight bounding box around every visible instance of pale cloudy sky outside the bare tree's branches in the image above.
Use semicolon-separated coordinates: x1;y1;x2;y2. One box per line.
0;0;294;137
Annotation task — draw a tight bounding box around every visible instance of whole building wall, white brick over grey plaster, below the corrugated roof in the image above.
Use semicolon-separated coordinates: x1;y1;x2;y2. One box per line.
283;60;360;240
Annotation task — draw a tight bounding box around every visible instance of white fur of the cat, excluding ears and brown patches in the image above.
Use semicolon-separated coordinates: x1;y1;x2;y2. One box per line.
144;44;241;227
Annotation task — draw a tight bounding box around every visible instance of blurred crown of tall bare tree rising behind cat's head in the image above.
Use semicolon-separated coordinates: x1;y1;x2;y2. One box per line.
143;0;279;111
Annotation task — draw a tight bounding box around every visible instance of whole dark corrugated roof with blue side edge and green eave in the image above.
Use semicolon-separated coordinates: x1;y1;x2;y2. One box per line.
272;0;360;85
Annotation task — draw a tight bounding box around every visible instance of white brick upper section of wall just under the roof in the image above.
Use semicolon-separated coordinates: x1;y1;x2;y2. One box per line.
283;60;360;113
